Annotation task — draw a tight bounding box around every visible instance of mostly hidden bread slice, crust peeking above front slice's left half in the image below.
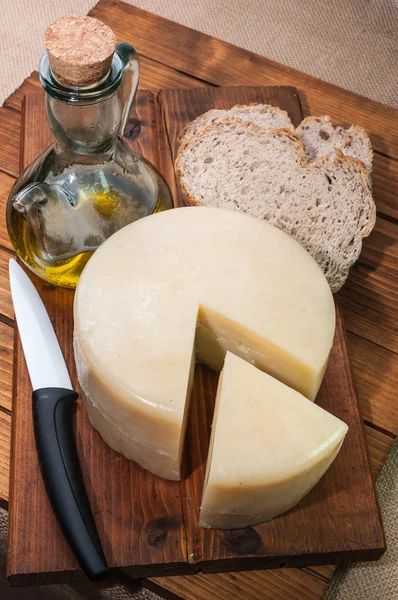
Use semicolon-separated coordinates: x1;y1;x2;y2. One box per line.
180;103;294;144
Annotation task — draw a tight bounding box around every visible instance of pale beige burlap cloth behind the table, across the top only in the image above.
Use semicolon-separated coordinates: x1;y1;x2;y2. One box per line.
0;0;398;106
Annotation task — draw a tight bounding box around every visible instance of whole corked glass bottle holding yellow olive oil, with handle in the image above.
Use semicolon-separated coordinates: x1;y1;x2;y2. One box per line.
7;17;172;288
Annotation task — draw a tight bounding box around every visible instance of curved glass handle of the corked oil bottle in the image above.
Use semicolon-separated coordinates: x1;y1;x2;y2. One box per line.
116;42;140;137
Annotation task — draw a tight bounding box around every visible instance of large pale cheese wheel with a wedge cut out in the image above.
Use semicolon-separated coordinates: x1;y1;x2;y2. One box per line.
74;207;335;479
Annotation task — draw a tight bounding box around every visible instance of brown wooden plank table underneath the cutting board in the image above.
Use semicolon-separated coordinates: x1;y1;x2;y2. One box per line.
0;0;398;600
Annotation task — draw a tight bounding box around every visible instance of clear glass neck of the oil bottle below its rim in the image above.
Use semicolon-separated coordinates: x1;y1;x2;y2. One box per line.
46;90;123;154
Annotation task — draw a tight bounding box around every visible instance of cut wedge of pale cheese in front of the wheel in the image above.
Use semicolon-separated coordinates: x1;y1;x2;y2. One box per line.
200;352;348;529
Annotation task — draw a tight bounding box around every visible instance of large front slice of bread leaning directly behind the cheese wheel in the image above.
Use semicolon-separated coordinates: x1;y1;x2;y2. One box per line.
176;118;376;292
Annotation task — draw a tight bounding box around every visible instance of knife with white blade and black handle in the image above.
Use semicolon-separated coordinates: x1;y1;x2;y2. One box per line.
9;259;108;581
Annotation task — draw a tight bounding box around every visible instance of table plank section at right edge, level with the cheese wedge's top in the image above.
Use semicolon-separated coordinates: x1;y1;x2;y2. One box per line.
347;333;398;435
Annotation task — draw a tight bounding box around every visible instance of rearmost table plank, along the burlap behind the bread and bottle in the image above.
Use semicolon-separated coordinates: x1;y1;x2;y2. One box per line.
90;0;398;158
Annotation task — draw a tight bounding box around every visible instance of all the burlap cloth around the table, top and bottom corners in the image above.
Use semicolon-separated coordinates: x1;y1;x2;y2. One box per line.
0;0;398;600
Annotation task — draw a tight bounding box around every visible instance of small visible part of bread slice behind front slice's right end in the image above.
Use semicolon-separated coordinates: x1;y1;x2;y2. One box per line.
295;116;373;173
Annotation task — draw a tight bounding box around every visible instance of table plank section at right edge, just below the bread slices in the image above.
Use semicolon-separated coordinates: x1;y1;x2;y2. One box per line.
339;263;398;352
